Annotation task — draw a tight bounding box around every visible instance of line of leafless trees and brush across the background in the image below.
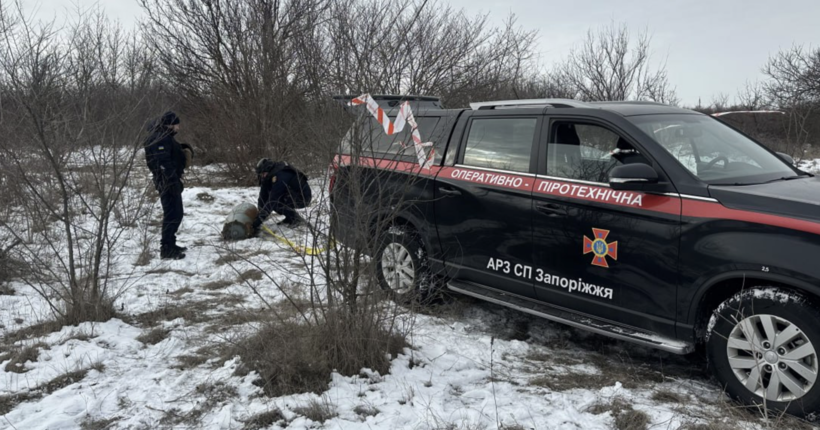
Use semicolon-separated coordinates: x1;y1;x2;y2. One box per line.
0;0;820;181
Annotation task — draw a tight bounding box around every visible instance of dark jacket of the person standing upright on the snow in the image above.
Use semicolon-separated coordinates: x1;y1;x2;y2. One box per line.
145;126;186;192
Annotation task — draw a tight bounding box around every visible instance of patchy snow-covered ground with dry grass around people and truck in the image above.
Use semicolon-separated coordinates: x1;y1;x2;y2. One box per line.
0;165;809;429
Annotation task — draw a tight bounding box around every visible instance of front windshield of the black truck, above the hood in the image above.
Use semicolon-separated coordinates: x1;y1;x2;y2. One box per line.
628;114;802;185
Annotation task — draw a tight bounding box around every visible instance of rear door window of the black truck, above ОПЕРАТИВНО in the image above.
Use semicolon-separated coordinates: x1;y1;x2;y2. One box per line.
463;118;538;172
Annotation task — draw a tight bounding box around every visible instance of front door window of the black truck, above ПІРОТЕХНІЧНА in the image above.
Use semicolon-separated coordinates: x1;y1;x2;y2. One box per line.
547;121;650;183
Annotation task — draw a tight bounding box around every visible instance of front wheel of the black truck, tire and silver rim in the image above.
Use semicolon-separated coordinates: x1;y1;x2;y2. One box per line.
706;288;820;418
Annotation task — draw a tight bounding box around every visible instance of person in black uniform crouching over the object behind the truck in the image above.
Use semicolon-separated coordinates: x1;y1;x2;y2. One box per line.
253;158;311;234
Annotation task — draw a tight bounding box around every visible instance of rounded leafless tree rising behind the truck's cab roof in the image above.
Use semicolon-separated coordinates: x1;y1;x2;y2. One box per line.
556;23;678;104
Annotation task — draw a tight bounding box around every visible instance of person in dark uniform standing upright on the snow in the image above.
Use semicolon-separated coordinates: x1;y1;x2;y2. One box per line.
145;111;193;260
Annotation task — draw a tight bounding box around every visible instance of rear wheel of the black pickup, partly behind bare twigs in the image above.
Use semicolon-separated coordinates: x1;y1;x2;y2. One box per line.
375;226;431;302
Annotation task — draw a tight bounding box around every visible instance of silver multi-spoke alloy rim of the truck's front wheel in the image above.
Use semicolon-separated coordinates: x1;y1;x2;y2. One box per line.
726;315;817;402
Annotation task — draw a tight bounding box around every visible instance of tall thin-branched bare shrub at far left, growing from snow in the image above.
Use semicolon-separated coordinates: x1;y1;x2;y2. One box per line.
0;1;160;323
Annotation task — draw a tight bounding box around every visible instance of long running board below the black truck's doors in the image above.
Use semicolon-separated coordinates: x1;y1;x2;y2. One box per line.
447;280;694;355
